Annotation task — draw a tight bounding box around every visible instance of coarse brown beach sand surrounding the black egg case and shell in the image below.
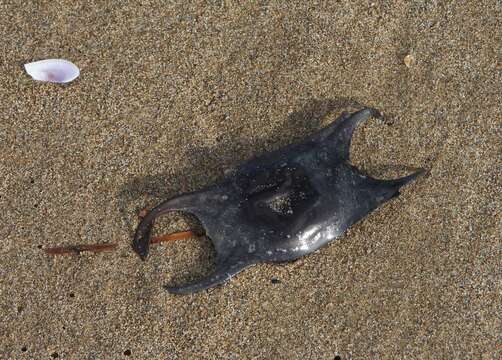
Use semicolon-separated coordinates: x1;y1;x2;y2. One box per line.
0;0;502;359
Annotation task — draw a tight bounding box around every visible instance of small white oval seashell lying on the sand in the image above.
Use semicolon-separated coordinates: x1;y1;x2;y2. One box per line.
24;59;80;83
